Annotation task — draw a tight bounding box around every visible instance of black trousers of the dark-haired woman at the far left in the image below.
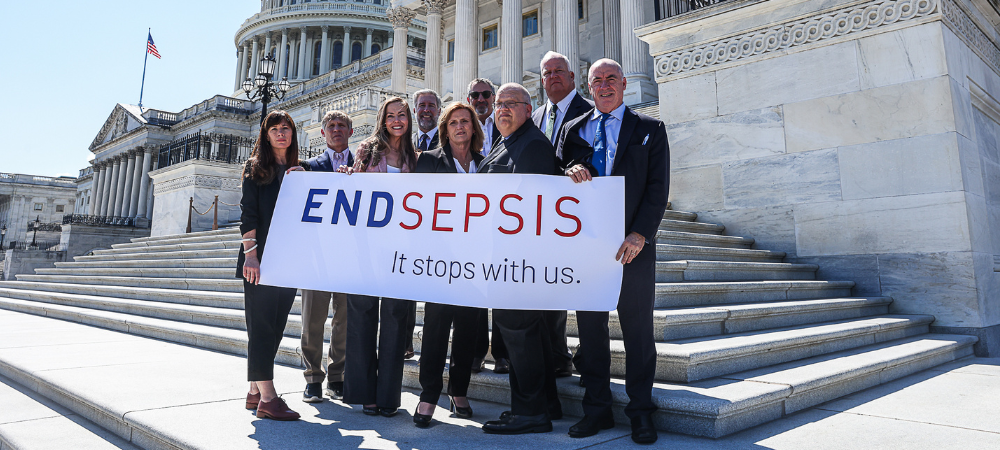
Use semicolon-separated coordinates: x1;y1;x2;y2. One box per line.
243;280;295;381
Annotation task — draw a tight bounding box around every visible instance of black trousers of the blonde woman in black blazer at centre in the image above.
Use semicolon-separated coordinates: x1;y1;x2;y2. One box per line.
420;302;479;404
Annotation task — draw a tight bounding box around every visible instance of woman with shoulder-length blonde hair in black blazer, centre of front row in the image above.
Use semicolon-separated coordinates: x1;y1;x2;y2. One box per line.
413;103;484;428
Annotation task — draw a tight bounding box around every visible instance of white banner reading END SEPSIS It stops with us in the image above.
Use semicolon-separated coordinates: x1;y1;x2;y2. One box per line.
261;172;625;311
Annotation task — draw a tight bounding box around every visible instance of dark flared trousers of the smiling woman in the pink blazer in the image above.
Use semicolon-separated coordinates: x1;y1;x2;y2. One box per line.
344;294;413;408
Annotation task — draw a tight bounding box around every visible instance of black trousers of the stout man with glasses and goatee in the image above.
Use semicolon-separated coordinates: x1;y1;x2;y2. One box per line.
493;309;561;416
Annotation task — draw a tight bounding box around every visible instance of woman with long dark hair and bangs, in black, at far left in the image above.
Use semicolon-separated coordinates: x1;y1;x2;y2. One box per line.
236;111;299;420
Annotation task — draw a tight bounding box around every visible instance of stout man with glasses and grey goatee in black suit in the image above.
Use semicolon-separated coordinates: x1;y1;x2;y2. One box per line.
479;83;562;434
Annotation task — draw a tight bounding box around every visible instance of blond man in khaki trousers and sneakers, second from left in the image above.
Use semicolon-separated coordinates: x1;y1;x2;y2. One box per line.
300;111;354;403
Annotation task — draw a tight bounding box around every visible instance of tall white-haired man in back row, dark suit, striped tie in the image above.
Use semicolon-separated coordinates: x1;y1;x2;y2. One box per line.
531;52;594;377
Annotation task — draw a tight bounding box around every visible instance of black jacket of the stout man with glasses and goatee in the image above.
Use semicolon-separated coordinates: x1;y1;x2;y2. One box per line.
479;120;556;175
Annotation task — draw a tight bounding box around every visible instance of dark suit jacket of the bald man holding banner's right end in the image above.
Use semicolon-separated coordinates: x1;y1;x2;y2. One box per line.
557;107;670;243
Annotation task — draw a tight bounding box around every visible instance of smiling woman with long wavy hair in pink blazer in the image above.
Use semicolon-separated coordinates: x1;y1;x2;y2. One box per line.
338;97;417;417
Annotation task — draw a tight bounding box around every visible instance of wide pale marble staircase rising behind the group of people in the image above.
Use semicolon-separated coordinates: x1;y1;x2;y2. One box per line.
0;210;975;437
